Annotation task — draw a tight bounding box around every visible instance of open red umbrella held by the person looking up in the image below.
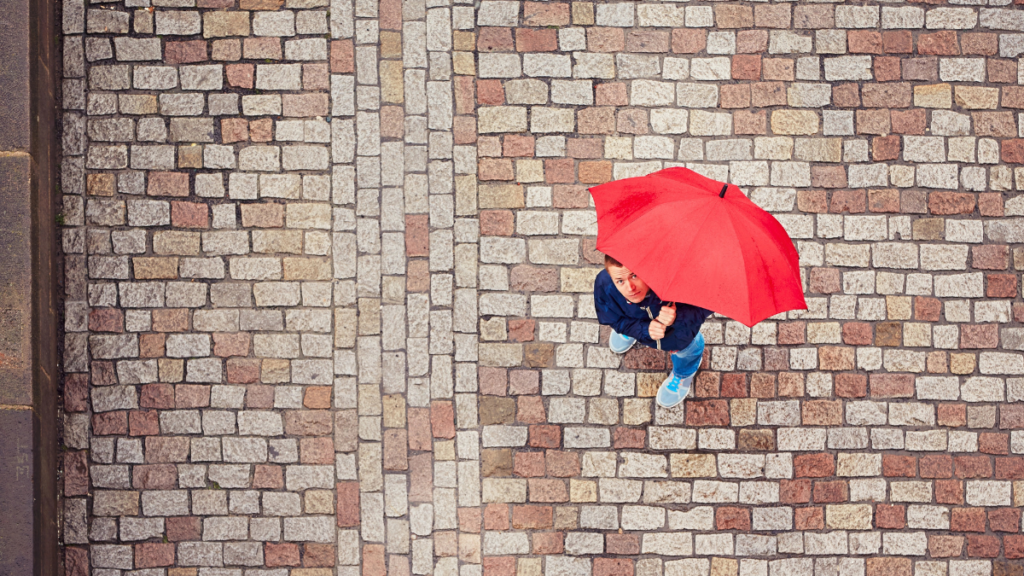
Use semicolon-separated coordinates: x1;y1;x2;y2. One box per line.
590;168;807;326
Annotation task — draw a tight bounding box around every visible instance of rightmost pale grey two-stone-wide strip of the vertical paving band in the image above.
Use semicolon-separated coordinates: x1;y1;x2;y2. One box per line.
425;1;482;576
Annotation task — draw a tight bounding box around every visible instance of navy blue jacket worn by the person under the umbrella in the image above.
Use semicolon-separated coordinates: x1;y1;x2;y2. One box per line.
594;270;712;351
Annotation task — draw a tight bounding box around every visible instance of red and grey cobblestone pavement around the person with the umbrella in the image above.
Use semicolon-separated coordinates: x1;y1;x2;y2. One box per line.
61;0;1024;576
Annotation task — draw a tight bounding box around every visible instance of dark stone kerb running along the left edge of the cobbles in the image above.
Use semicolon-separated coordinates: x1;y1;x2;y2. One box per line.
0;0;62;565
